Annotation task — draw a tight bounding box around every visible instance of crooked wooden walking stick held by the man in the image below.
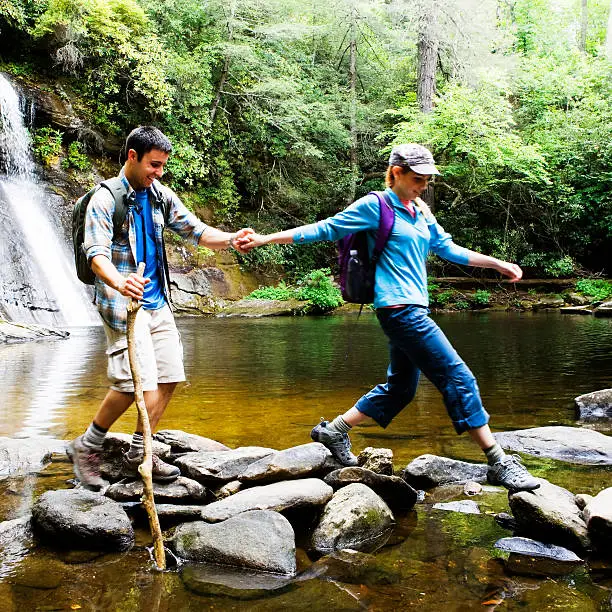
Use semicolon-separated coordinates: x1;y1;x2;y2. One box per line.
127;262;166;570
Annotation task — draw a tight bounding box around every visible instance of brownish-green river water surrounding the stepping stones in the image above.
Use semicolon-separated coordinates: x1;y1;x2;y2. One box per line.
0;312;612;612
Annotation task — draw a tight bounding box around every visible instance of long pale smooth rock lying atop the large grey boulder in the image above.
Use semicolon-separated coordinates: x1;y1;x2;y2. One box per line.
202;478;334;523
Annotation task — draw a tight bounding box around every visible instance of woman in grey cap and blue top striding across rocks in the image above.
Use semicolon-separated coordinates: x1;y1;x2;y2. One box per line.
243;144;540;490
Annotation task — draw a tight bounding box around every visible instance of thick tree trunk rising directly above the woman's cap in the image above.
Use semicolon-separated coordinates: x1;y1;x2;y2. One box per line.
417;0;440;113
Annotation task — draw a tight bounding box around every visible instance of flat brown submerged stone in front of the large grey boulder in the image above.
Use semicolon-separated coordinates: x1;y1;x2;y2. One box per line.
181;564;292;601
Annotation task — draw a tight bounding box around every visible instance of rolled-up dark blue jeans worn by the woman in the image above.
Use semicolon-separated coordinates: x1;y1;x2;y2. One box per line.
355;306;489;433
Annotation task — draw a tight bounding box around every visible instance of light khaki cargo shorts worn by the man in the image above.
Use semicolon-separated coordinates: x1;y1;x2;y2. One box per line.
104;304;185;393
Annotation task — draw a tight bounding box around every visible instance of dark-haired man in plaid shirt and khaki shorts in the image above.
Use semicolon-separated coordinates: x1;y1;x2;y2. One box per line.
71;126;249;491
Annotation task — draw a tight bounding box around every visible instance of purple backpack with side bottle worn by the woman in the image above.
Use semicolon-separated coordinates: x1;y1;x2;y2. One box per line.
338;191;395;305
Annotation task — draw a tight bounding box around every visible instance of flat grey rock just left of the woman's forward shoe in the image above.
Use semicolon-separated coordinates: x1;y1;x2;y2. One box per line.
401;455;487;489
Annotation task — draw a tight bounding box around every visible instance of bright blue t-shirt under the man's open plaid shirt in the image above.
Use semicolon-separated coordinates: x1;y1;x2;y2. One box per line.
133;189;166;310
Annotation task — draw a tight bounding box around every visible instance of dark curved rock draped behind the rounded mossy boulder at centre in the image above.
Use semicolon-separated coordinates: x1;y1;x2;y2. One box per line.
323;467;417;510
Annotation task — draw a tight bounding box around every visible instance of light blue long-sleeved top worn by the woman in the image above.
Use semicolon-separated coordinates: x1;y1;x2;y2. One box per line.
293;189;468;308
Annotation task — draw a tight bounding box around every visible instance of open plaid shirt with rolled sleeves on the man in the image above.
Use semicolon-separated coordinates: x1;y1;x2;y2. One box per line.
84;169;207;332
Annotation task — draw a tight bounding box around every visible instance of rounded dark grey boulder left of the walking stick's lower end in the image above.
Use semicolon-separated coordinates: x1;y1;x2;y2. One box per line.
32;489;134;551
